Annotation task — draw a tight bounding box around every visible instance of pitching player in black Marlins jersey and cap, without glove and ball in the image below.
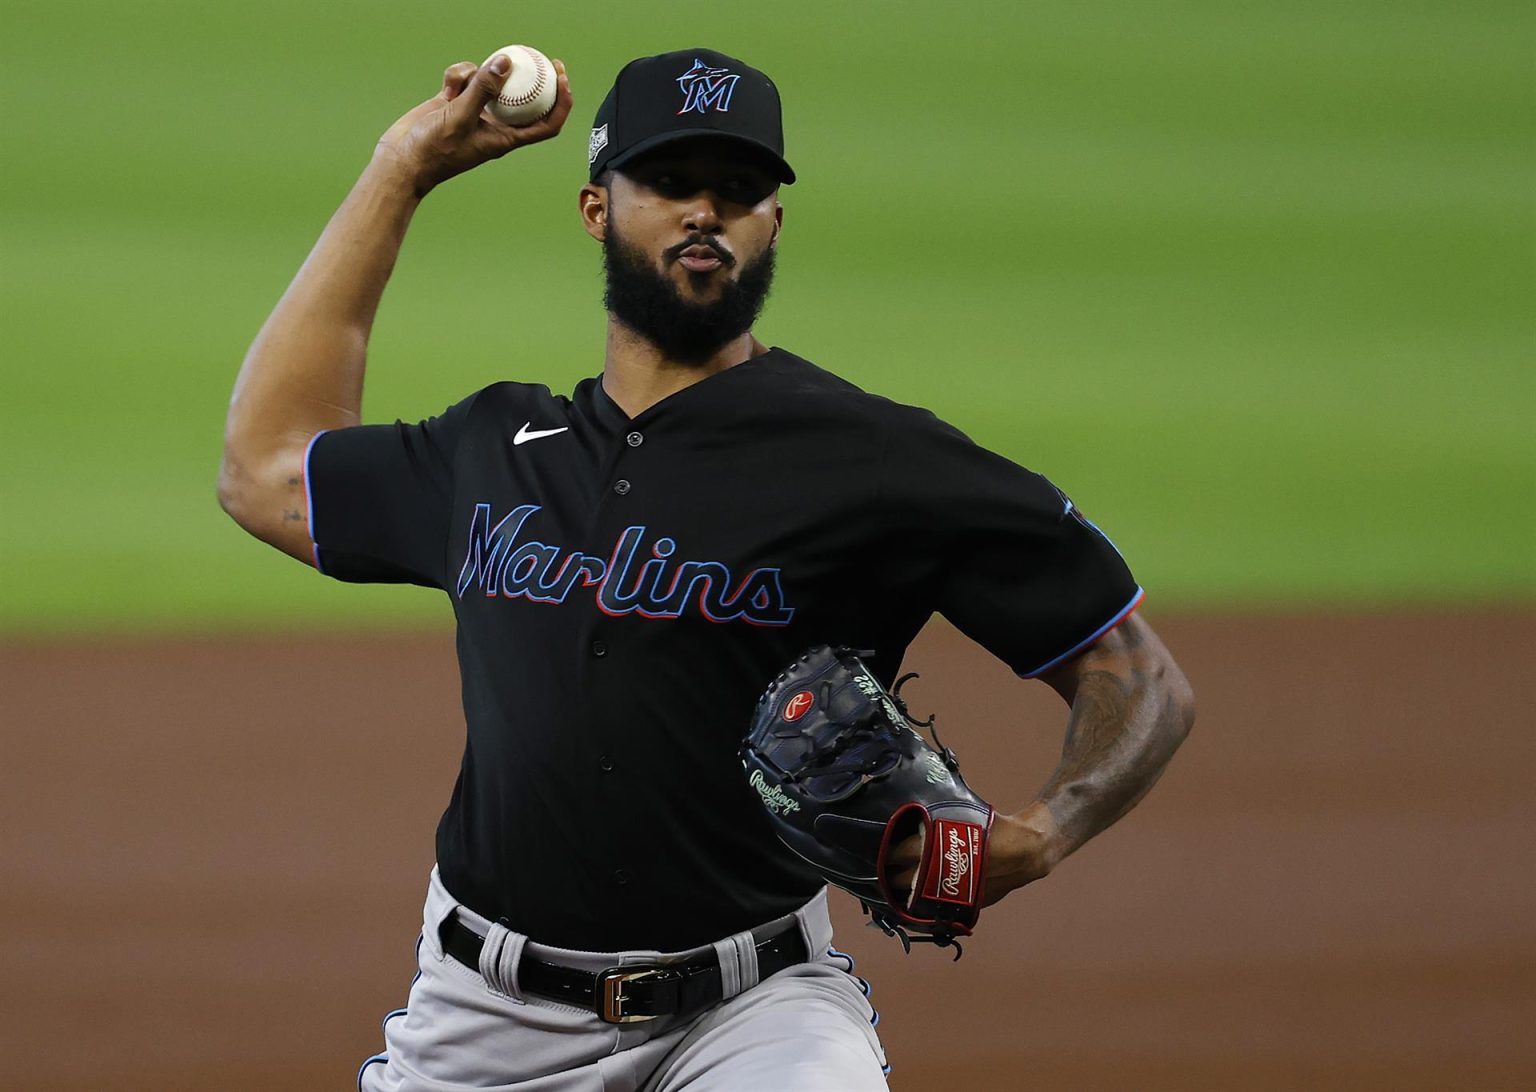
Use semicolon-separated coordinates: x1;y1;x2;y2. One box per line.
220;49;1193;1092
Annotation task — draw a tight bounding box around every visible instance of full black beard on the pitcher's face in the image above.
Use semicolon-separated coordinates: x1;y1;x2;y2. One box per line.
602;221;774;364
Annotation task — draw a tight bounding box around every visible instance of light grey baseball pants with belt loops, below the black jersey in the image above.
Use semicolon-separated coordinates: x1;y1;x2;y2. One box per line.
358;869;886;1092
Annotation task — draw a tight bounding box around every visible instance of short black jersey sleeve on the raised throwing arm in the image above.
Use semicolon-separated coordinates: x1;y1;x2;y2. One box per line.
304;396;475;588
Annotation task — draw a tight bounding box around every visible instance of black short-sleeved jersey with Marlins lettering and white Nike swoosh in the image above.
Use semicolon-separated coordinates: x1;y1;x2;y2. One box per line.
306;349;1141;951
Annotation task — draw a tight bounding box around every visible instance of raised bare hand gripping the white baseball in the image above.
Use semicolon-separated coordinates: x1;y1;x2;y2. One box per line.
375;54;571;195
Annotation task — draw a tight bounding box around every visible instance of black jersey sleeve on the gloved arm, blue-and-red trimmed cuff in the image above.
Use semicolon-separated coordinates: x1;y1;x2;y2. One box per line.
882;410;1143;677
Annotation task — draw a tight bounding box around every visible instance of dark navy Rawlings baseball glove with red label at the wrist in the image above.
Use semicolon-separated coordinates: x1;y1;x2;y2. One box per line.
742;645;992;958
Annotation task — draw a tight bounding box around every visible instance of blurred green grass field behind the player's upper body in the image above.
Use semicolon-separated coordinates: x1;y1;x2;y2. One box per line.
0;0;1536;633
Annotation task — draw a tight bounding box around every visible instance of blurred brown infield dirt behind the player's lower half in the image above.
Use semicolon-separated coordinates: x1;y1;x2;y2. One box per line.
0;611;1536;1092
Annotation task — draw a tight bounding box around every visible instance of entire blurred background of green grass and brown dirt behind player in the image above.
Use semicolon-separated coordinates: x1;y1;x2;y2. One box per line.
0;0;1536;1089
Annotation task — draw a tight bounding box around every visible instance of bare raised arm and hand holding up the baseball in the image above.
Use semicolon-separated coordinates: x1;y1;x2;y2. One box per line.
218;55;571;564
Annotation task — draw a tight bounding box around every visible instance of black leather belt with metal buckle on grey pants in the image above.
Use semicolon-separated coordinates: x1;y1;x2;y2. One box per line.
439;914;809;1024
